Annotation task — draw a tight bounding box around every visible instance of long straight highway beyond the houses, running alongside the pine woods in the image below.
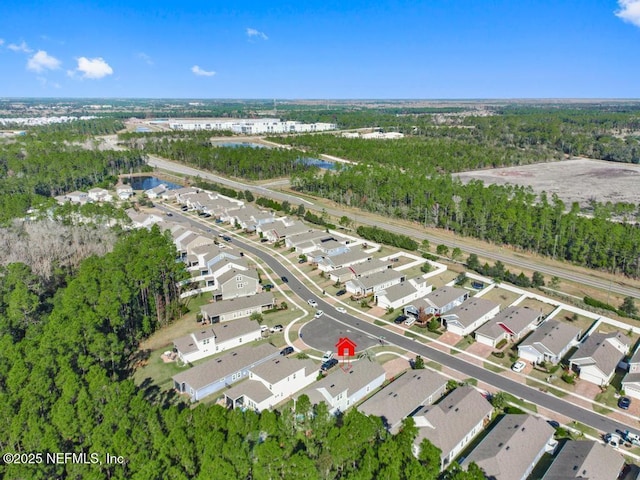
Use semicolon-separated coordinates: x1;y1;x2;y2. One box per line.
148;155;640;299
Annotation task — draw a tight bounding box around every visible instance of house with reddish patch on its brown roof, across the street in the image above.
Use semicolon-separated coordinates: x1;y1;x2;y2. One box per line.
475;307;544;348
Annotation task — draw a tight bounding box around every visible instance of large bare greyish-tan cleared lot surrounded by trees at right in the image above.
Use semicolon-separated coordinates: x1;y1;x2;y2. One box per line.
456;158;640;208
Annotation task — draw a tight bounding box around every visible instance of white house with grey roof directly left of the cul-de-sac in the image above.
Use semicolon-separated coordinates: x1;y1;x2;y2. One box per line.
173;318;262;362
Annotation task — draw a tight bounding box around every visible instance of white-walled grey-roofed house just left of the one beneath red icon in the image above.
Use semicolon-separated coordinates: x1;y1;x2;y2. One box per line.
224;356;318;412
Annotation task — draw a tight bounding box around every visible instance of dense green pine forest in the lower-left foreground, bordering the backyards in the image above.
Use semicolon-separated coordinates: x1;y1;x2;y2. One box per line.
0;228;484;480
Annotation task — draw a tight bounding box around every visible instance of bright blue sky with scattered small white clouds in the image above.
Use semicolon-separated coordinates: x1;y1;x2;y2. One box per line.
0;0;640;99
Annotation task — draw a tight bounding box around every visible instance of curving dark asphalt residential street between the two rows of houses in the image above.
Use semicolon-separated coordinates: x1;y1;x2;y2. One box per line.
158;205;640;440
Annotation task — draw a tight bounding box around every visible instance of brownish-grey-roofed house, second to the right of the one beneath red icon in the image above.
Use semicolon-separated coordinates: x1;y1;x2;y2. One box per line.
413;386;493;470
